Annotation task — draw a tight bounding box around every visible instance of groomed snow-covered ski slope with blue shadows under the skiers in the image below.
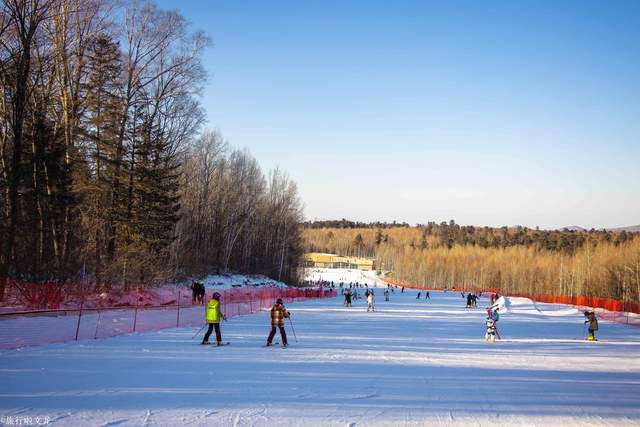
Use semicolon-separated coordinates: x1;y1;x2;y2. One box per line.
0;290;640;427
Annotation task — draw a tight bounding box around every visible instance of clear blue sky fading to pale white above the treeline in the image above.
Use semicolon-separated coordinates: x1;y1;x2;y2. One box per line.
158;0;640;228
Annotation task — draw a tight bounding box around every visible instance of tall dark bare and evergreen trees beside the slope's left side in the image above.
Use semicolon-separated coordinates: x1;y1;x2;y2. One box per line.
0;0;302;295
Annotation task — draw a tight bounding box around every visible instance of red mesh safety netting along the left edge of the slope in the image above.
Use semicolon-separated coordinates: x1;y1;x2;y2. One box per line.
0;284;336;349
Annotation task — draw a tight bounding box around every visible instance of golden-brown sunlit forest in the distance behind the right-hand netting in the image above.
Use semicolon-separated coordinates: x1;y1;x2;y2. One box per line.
303;221;640;302
